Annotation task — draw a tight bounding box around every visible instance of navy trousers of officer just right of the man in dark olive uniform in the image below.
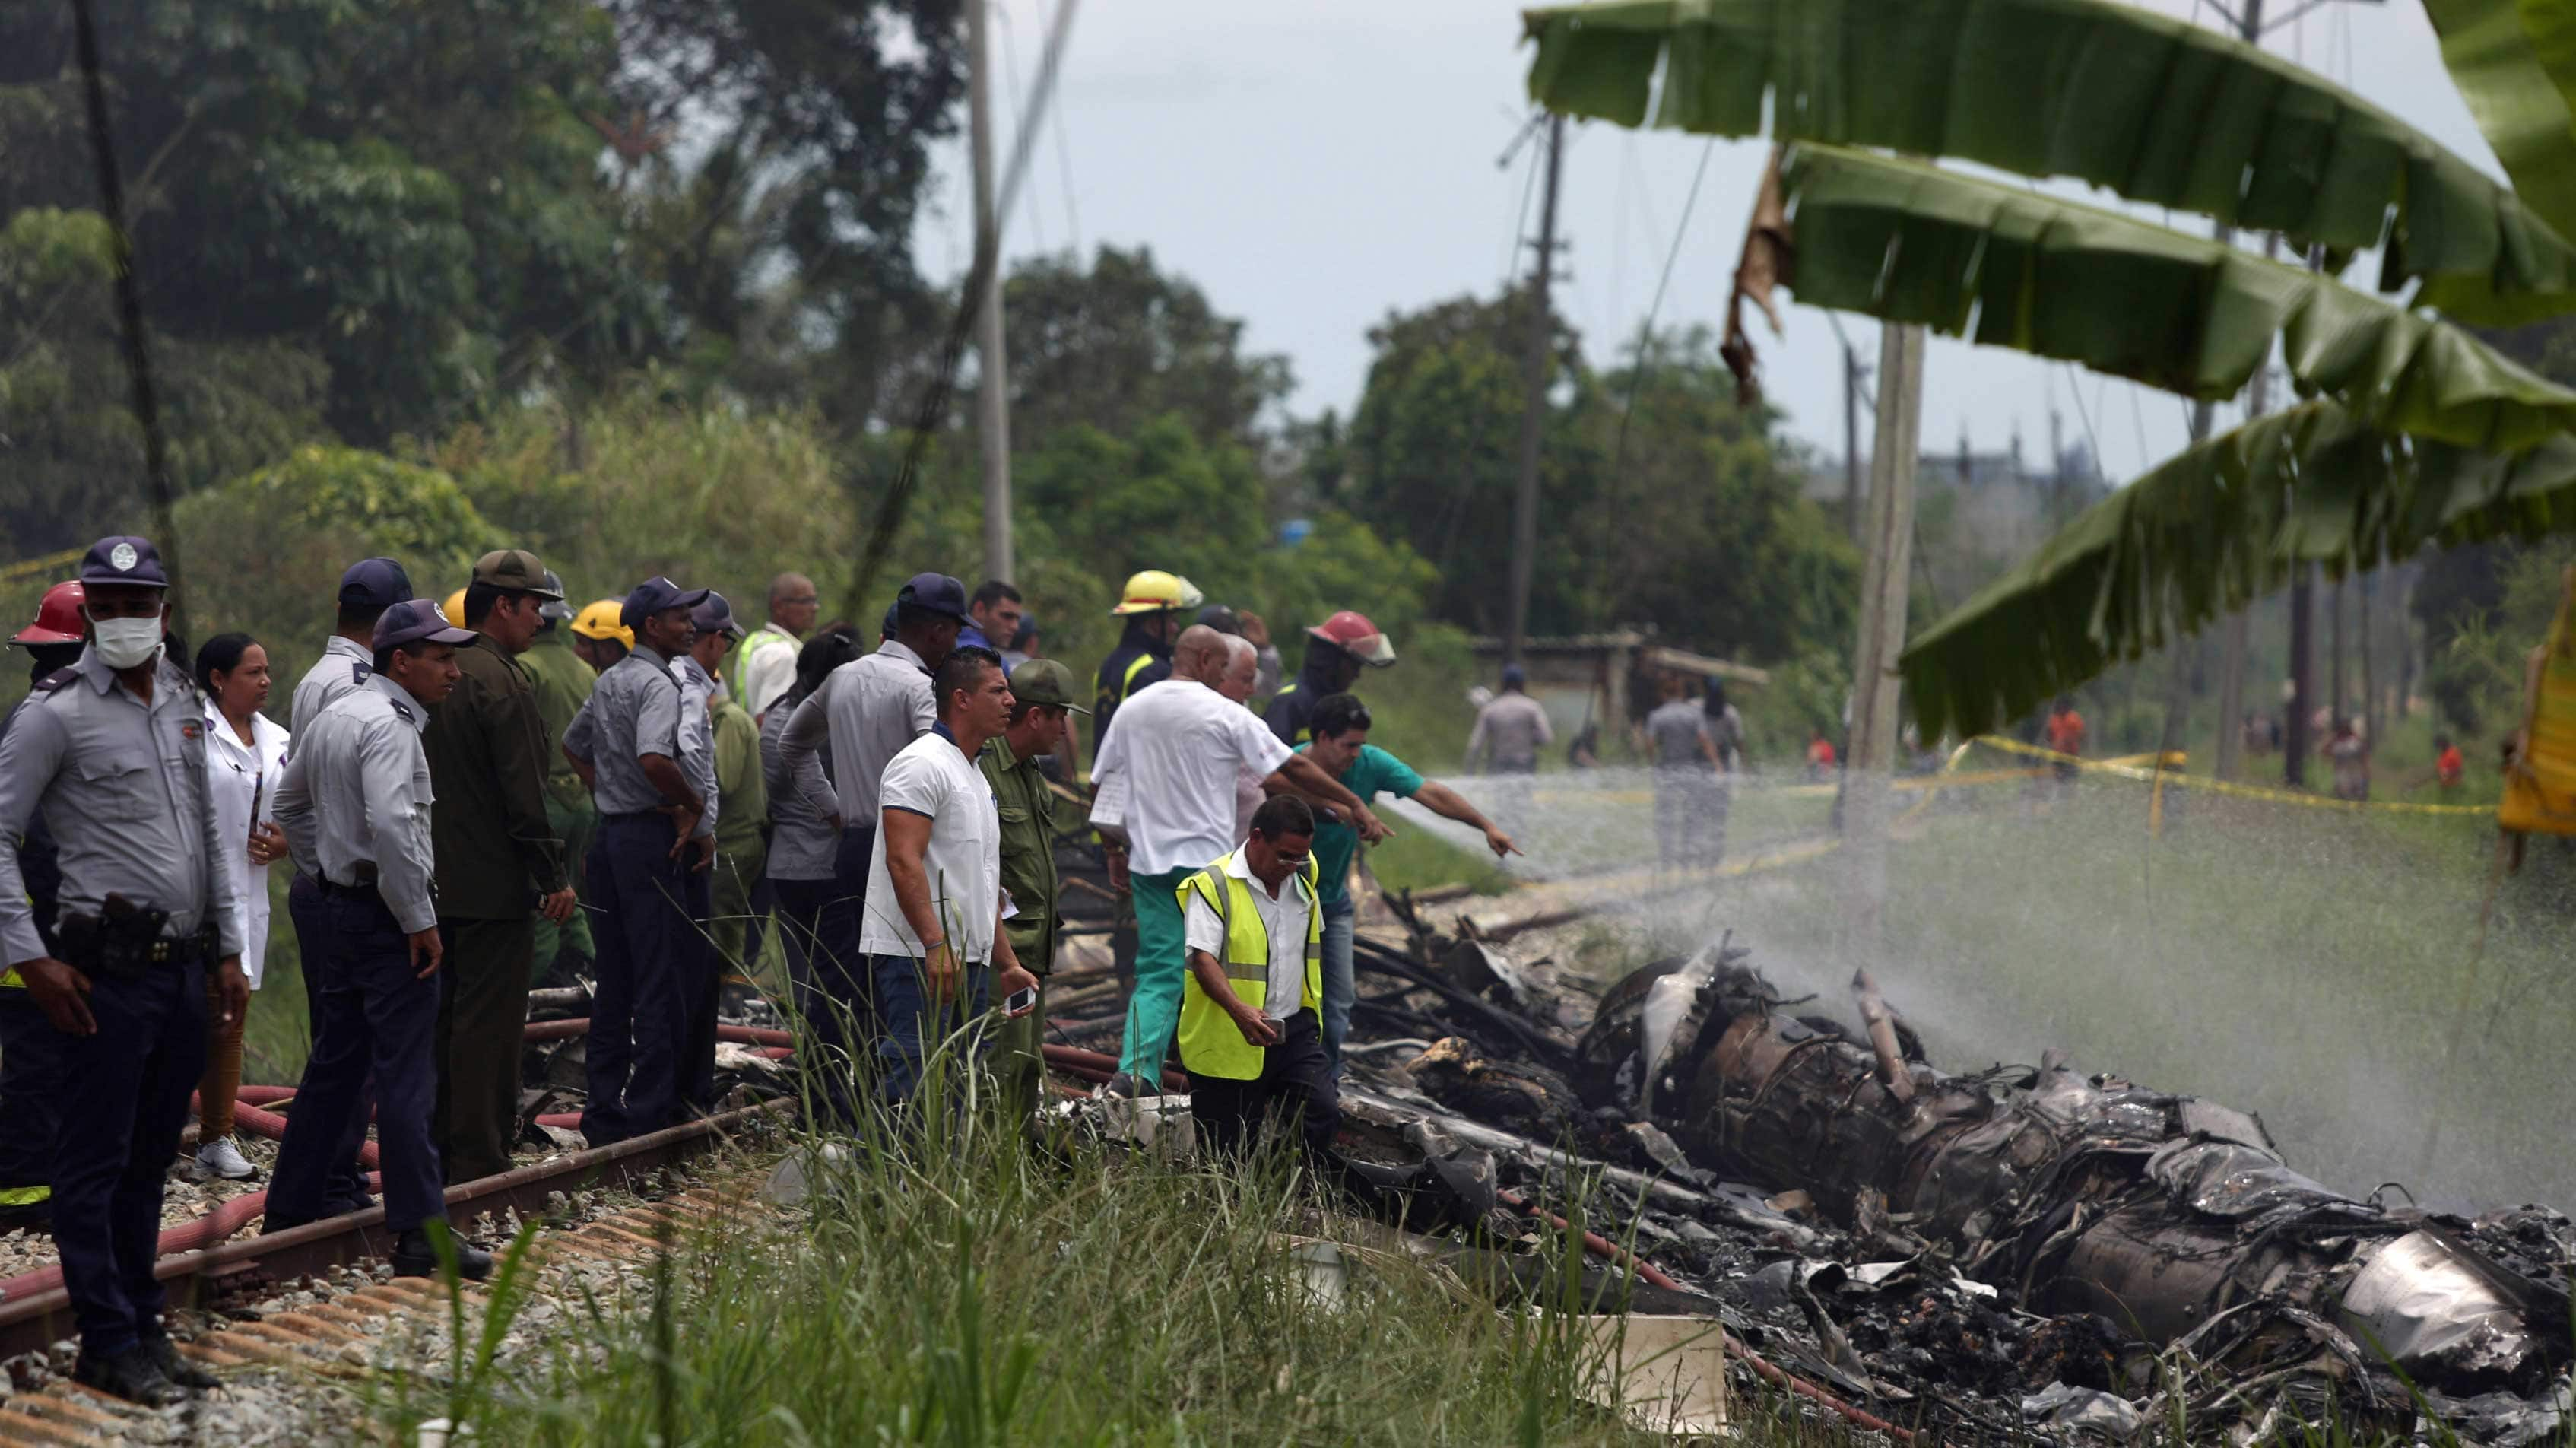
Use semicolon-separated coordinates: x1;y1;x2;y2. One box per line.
582;814;713;1147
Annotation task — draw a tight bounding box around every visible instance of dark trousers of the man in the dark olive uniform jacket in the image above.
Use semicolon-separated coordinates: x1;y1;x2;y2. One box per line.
430;915;536;1183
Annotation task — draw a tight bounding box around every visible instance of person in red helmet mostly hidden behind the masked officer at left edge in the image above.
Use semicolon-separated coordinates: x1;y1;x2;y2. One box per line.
0;577;87;1231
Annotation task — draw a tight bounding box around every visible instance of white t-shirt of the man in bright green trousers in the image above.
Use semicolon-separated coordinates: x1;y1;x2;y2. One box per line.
1093;678;1288;876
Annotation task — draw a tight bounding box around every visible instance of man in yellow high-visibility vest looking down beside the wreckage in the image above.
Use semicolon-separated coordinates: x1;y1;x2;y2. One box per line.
1177;793;1342;1160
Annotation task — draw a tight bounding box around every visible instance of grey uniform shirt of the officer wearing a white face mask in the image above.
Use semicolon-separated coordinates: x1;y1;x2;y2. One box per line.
0;639;250;966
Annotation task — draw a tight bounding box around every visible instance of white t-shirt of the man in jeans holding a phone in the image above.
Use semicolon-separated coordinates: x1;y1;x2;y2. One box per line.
858;724;1002;966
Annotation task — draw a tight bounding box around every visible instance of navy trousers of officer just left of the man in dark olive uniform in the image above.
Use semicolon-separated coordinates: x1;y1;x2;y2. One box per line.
268;889;449;1231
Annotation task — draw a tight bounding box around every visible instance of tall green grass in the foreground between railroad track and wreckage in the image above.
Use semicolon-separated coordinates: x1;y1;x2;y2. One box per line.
376;1081;1679;1448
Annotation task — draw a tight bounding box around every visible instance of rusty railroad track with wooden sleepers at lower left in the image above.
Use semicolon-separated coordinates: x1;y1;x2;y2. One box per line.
0;1100;796;1448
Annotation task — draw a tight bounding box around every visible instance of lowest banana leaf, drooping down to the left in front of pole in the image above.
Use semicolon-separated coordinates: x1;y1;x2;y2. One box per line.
1899;399;2576;739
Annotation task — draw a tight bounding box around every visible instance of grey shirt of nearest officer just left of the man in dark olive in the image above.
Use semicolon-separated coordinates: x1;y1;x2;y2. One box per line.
276;675;438;935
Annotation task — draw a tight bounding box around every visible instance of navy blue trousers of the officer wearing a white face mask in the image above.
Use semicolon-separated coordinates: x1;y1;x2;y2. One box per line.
54;964;206;1355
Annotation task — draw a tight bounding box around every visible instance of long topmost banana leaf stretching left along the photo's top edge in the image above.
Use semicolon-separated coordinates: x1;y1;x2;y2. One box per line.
1522;0;2576;325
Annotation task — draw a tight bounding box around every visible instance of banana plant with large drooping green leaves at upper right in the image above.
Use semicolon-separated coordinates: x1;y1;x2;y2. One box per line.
1528;0;2576;735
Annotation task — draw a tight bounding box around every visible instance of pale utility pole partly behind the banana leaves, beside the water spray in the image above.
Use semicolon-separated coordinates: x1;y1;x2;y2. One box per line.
1842;327;1924;966
